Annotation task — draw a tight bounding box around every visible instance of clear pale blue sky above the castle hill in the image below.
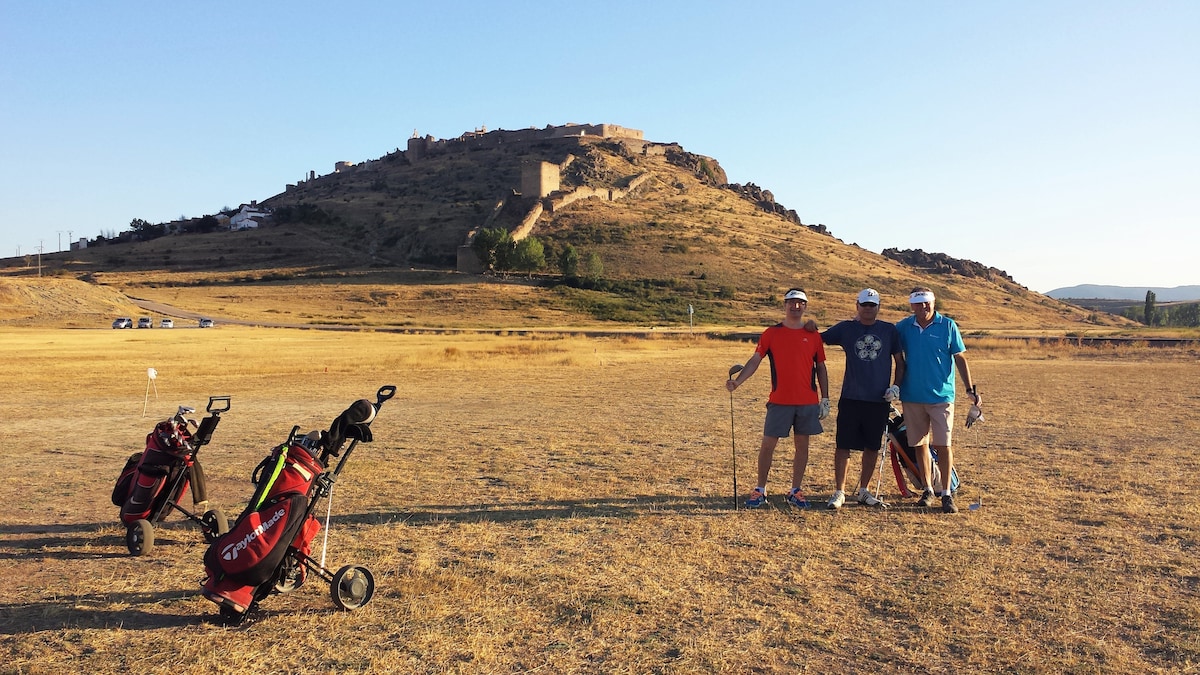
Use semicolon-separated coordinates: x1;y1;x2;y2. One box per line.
0;0;1200;292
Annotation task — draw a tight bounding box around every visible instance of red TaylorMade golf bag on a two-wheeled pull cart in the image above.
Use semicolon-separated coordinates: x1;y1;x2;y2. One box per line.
200;386;396;623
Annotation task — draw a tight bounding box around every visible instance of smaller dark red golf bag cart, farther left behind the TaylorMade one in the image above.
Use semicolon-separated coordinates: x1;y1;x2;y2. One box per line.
113;396;229;555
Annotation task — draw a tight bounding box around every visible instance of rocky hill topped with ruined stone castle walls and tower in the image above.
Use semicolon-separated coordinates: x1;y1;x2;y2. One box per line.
0;127;1123;328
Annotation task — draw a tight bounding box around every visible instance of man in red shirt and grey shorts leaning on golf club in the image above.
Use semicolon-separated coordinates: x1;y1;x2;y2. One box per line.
725;288;829;508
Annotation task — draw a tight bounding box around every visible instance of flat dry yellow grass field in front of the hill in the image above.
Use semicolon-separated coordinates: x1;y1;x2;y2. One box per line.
0;327;1200;674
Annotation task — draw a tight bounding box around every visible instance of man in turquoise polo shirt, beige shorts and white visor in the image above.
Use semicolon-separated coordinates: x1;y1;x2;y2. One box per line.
896;286;982;513
